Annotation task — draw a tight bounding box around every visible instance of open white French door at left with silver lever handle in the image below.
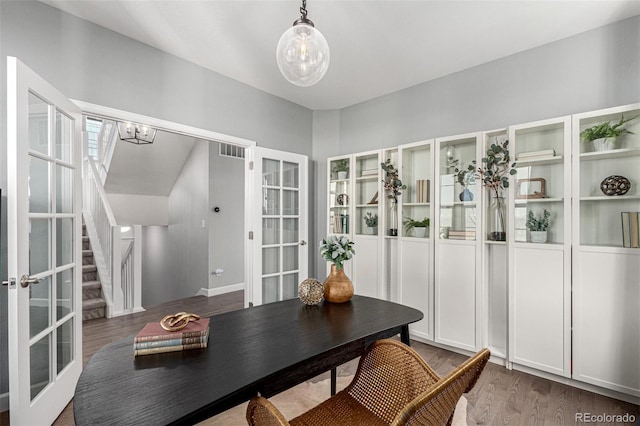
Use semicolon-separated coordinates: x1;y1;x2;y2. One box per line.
7;57;82;425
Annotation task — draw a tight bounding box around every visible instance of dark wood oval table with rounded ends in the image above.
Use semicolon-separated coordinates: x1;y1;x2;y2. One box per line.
73;295;423;426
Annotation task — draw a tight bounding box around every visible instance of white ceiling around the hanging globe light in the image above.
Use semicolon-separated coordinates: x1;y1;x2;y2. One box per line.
42;0;640;110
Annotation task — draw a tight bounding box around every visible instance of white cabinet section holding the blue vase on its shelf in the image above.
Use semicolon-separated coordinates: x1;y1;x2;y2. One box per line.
434;133;482;351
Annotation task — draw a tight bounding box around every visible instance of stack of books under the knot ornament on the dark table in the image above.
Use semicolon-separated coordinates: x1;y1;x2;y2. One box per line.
133;318;209;356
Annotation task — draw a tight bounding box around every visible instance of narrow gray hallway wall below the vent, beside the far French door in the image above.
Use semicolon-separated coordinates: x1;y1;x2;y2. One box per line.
209;143;245;289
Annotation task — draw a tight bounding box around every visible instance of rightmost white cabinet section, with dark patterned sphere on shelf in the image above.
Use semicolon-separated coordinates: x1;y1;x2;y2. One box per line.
572;104;640;397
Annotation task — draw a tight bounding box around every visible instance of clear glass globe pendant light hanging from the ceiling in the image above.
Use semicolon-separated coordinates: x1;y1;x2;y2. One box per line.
276;0;329;87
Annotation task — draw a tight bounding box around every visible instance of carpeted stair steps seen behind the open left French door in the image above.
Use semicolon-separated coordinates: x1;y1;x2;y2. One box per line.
82;224;107;321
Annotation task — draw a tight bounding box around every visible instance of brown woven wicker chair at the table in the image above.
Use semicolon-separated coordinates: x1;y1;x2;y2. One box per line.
247;340;490;426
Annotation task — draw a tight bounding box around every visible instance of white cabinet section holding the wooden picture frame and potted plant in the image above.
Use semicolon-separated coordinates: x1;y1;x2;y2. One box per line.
507;117;571;377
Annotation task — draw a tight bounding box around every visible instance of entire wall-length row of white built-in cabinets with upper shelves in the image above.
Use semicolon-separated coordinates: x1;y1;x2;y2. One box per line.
327;104;640;402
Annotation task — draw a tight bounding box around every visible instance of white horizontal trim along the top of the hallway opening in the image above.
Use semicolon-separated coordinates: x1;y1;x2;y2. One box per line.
71;99;256;147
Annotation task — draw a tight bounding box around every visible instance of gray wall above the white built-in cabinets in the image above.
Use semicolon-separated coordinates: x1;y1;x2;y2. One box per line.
313;16;640;275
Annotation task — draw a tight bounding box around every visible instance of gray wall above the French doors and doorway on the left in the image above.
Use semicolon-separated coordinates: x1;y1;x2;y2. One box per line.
0;0;312;400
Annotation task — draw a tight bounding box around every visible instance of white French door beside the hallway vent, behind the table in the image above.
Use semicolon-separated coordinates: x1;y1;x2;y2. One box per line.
245;147;309;305
